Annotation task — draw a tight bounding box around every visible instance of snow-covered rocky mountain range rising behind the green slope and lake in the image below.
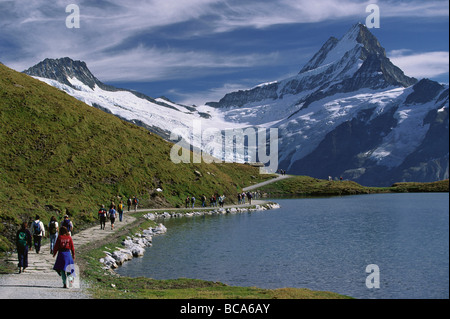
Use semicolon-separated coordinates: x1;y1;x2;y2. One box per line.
20;24;449;186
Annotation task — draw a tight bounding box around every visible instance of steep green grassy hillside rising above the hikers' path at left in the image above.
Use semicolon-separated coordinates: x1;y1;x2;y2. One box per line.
0;65;270;251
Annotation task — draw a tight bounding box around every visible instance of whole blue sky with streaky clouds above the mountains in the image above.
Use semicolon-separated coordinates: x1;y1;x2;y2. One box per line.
0;0;449;104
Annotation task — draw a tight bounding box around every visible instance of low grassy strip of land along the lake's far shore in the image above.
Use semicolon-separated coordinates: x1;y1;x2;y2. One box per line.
255;176;449;197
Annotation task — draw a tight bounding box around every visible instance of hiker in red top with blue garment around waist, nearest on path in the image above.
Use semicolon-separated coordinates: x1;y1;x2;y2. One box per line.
53;226;75;288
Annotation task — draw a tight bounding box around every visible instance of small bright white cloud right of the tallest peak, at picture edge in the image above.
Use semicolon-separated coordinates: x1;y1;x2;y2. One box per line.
388;49;449;78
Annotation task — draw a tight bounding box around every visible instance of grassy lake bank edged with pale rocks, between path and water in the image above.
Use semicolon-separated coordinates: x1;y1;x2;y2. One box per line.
83;202;353;299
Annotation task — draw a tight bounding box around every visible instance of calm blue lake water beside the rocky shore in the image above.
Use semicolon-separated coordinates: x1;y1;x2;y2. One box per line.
117;193;449;299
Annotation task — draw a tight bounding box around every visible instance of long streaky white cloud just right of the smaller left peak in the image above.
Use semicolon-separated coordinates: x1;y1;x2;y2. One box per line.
85;45;277;81
